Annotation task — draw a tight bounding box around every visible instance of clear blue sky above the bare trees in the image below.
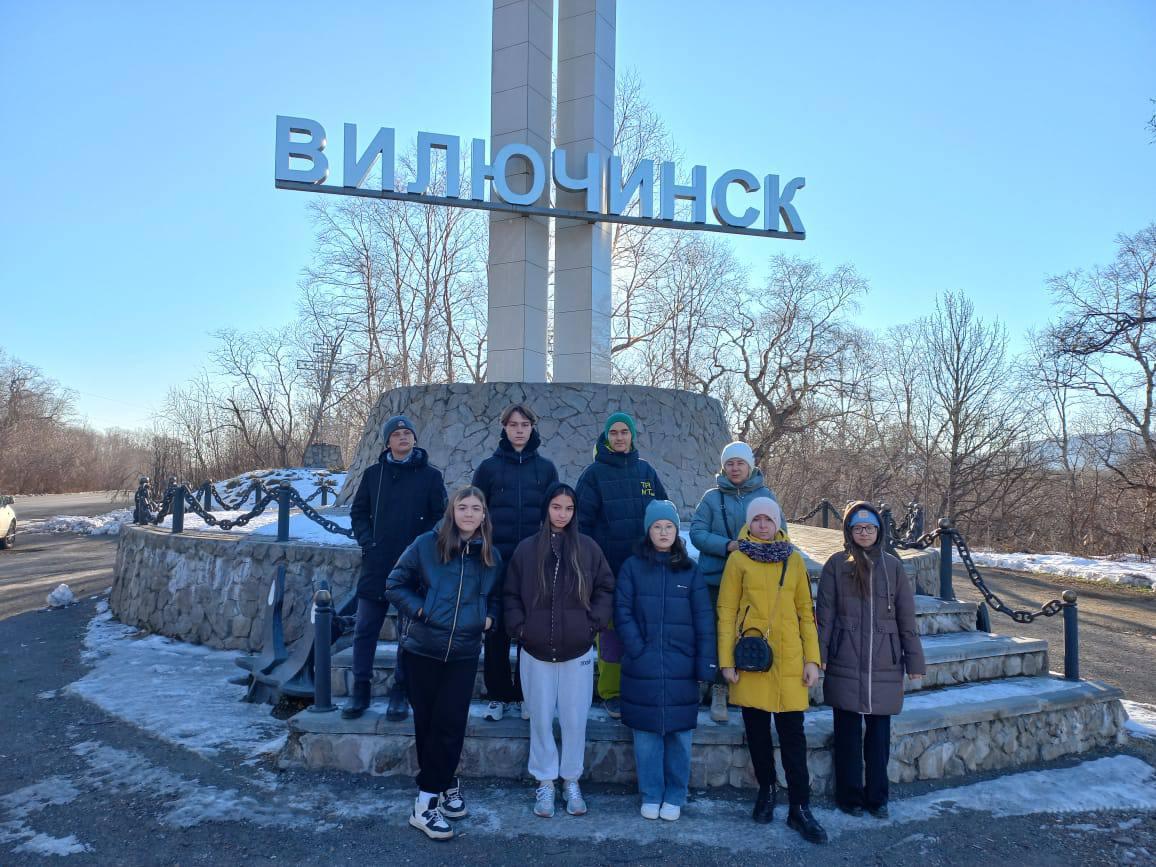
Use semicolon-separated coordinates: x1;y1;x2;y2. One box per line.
0;0;1156;427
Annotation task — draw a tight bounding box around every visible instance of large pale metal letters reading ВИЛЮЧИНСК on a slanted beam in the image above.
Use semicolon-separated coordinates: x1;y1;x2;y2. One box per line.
274;116;806;240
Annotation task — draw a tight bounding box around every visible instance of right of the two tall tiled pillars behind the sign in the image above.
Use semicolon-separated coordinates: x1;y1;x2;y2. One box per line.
554;0;616;383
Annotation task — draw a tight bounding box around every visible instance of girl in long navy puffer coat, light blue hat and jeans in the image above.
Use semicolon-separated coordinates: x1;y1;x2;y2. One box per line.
614;499;718;822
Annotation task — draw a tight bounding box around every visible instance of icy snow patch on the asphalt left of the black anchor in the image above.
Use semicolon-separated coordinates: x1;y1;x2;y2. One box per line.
67;602;284;756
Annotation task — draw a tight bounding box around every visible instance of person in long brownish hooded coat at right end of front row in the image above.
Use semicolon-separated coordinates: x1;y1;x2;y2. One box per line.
815;502;926;818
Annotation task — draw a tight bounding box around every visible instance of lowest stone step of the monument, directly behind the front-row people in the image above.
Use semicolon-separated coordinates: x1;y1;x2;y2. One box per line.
280;675;1125;792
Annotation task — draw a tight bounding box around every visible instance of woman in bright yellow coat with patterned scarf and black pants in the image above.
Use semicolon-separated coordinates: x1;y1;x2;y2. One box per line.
718;497;827;843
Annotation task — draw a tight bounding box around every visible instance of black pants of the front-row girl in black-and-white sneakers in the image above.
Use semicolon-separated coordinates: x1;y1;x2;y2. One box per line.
401;651;477;794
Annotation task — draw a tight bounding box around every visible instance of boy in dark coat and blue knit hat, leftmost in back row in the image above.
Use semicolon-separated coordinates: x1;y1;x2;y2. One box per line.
341;415;446;721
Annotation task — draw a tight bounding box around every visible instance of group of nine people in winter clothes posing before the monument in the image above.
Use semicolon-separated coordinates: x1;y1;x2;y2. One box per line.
342;405;925;843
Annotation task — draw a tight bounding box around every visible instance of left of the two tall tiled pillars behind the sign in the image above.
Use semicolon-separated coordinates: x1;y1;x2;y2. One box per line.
486;0;554;383
